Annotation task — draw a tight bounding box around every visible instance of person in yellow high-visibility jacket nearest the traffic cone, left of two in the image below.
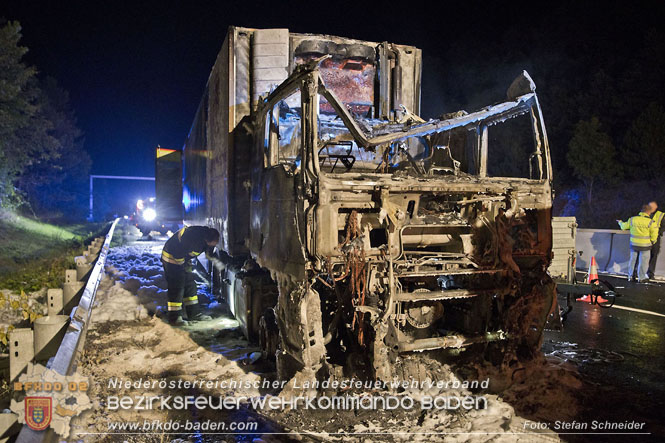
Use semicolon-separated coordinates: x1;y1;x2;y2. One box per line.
617;205;658;283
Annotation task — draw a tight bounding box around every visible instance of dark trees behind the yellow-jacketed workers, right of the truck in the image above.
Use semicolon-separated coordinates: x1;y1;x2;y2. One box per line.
556;30;665;229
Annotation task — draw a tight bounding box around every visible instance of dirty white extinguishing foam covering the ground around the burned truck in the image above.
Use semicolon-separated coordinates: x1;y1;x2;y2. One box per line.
72;242;580;442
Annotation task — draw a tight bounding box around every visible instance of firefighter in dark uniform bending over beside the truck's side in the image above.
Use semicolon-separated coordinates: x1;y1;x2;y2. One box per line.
162;226;219;326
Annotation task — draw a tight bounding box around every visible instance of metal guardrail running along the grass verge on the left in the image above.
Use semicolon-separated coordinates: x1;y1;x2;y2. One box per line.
9;219;119;443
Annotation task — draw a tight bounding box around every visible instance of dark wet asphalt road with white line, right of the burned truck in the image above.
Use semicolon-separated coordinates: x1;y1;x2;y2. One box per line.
543;276;665;442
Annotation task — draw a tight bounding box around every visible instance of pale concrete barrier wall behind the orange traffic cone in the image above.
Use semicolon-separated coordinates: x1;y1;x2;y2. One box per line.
575;229;665;277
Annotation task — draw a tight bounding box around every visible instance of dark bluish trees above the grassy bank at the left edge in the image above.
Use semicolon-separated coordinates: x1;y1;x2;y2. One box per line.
0;20;91;218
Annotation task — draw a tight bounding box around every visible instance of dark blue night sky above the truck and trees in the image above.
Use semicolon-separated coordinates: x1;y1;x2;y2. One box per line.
0;0;663;212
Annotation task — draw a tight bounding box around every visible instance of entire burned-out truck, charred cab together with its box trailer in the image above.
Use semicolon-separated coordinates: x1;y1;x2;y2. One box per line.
183;27;556;380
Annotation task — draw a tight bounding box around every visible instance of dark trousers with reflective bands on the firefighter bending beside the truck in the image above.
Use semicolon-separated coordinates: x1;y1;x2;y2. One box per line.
162;261;199;322
